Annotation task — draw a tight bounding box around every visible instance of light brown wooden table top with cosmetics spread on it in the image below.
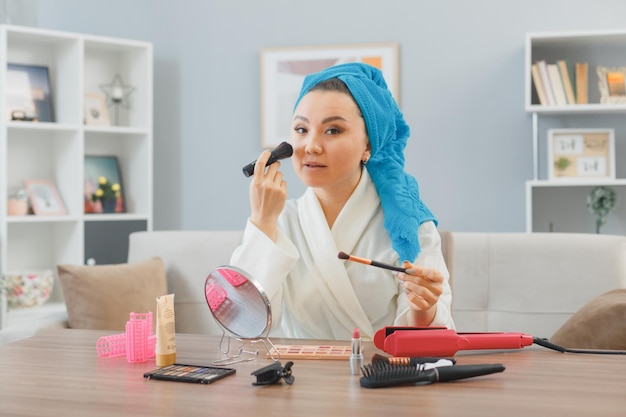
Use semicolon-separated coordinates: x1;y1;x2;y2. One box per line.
0;329;626;417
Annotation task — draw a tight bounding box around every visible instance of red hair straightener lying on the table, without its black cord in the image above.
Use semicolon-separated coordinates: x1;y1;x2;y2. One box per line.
374;326;534;357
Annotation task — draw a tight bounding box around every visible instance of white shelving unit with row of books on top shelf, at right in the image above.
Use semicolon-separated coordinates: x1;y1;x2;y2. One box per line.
525;30;626;232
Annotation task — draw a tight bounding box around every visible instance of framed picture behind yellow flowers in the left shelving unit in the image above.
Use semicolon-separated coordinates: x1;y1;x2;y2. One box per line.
84;155;126;213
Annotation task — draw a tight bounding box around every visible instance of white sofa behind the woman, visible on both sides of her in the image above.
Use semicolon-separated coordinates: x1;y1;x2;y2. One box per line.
128;231;626;338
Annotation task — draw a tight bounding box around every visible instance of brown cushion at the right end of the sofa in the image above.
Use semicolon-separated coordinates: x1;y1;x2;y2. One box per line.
550;289;626;350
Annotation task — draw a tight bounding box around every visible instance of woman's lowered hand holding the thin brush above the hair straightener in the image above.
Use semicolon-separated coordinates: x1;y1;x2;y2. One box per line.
398;261;443;326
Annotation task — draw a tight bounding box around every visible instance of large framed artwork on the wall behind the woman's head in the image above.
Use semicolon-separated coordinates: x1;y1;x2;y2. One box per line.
261;43;399;148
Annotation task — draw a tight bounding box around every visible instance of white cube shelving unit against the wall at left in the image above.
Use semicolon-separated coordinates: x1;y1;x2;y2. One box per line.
0;25;153;273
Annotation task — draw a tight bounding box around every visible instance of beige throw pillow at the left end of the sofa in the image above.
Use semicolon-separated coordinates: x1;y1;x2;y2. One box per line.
57;258;167;332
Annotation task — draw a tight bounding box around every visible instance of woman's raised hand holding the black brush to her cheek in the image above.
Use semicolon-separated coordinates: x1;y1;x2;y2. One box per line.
250;150;287;241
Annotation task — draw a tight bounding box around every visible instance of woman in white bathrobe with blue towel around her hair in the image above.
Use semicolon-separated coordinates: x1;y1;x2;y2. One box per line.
231;63;454;339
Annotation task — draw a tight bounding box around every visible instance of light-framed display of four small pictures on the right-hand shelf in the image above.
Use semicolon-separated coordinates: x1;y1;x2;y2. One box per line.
548;129;615;180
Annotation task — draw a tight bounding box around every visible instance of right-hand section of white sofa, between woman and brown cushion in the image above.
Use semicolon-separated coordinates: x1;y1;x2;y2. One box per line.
453;233;626;338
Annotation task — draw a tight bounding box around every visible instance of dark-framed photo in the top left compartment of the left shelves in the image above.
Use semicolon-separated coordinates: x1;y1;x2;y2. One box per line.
6;64;54;122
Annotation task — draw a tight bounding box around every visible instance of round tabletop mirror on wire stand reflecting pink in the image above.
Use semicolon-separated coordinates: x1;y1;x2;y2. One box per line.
204;266;276;365
